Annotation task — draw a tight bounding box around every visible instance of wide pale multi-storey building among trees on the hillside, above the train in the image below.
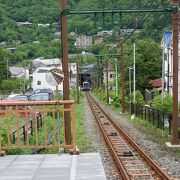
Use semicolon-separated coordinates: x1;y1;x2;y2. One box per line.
75;35;92;48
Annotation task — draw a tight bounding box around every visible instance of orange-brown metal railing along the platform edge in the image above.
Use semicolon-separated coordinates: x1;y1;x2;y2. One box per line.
0;100;76;155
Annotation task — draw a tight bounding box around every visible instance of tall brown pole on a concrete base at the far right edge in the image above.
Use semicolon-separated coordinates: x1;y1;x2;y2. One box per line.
172;0;179;145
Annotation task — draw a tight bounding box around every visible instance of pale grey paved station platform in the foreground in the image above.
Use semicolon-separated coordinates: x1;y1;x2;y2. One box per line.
0;153;106;180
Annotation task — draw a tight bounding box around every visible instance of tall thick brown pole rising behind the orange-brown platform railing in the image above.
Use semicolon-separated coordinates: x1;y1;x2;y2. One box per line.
61;0;71;145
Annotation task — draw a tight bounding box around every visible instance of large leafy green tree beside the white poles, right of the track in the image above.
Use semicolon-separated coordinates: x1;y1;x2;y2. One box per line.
125;39;162;94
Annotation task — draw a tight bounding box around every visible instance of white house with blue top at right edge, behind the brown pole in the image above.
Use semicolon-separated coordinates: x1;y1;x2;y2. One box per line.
161;31;180;101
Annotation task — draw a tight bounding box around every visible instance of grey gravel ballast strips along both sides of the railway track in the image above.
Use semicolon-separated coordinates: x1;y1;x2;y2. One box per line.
84;95;180;180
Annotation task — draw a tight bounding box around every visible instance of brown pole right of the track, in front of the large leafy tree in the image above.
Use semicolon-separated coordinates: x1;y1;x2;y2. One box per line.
120;44;126;113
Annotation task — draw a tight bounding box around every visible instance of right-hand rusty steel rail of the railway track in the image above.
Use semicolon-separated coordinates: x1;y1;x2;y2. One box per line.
87;93;172;180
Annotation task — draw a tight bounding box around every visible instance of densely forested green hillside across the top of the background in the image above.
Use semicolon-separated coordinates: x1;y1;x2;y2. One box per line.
0;0;171;64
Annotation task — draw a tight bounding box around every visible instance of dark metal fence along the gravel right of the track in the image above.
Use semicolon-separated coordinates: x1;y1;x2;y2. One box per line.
127;103;172;134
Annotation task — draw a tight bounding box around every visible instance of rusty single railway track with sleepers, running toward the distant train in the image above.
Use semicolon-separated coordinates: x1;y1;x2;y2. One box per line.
86;93;174;180
